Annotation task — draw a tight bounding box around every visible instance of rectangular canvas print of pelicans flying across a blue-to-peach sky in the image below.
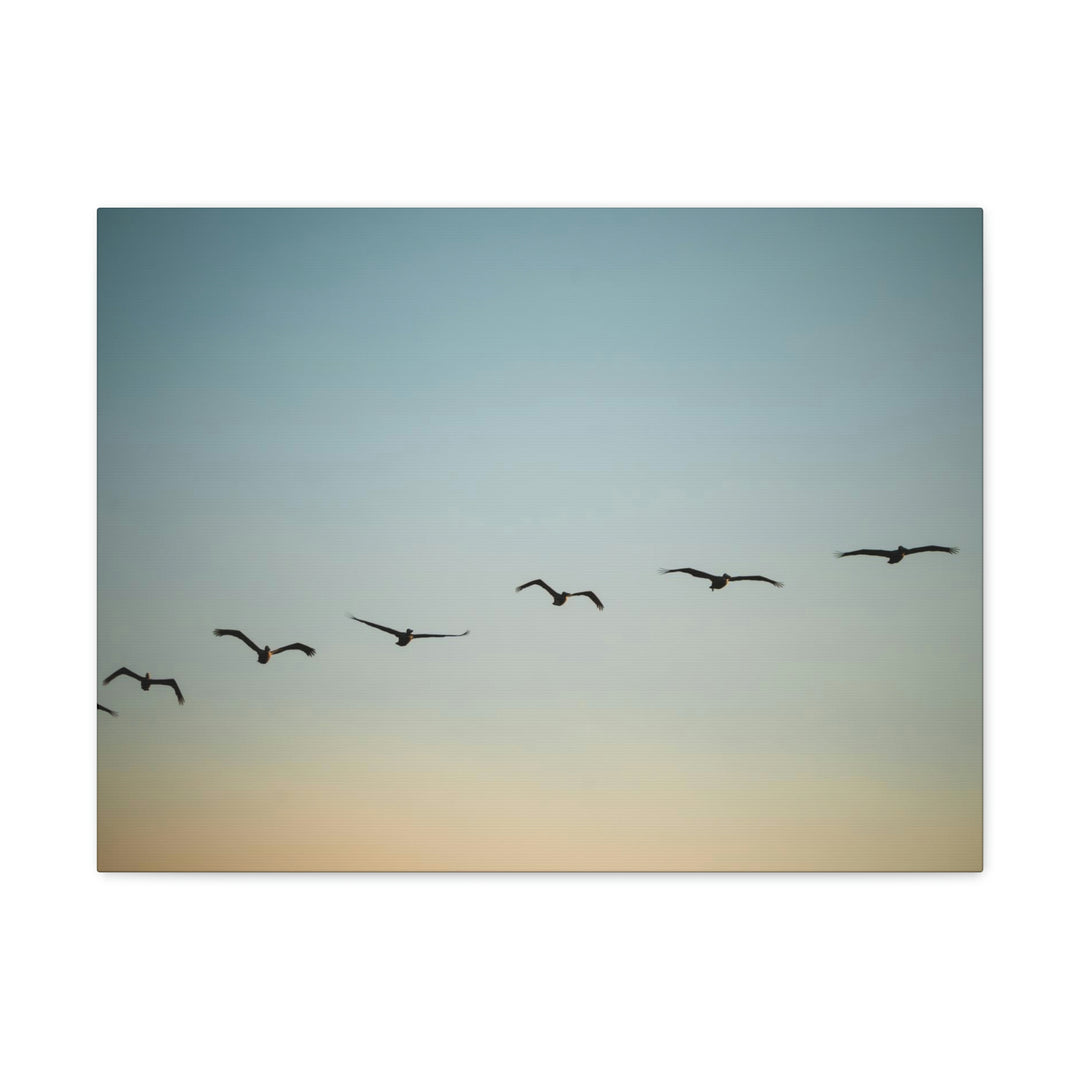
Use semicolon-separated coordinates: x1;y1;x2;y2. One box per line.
96;208;983;872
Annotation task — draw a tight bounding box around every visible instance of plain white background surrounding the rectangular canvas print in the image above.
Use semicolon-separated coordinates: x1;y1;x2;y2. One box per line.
0;2;1080;1078
